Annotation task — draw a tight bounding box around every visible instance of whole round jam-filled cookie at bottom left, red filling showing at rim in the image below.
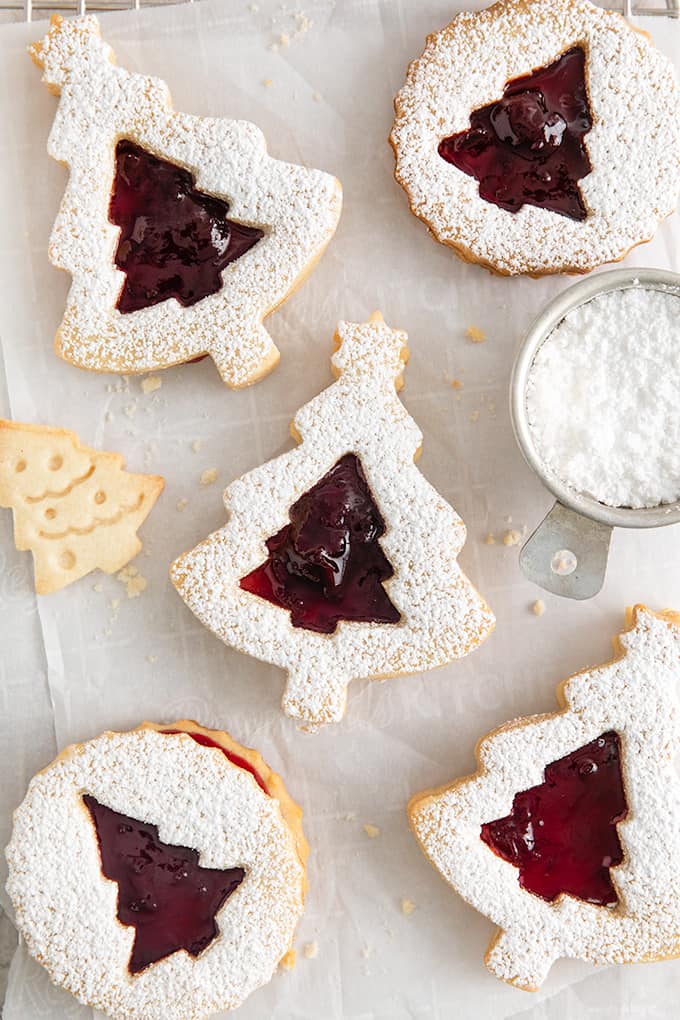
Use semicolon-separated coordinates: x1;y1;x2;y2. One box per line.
6;720;308;1020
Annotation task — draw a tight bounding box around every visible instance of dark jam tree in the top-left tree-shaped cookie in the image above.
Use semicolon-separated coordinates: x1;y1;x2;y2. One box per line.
109;139;264;312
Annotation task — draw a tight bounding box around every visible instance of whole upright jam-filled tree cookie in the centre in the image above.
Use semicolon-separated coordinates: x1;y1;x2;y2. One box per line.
171;313;493;729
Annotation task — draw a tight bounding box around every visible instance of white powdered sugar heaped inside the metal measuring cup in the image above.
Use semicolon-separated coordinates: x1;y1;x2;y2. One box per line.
526;287;680;507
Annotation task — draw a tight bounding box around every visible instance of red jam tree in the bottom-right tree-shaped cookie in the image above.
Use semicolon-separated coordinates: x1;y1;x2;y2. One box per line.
481;731;628;906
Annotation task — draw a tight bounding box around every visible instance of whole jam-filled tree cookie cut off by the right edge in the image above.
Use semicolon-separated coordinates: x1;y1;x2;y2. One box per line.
409;606;680;990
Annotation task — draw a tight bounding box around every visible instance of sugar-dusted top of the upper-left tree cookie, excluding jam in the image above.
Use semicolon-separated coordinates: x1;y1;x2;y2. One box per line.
32;16;342;387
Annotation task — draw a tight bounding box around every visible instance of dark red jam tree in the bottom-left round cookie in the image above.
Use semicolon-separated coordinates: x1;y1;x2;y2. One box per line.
83;795;246;974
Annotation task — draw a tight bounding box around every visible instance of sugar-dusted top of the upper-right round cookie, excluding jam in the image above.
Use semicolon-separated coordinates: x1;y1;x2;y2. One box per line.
390;0;680;274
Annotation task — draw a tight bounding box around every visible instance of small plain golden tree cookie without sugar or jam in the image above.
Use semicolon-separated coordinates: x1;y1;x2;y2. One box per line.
0;419;164;595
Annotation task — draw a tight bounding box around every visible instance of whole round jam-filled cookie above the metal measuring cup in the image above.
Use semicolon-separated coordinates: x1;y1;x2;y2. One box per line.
390;0;680;276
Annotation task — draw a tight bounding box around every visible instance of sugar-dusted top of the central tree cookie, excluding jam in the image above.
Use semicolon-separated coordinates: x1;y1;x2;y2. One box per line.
171;316;493;728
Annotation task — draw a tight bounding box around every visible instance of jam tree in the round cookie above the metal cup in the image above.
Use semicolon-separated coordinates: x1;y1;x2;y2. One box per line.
438;46;592;219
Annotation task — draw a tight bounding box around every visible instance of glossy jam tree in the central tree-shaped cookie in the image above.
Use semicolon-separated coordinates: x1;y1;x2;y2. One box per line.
240;453;401;633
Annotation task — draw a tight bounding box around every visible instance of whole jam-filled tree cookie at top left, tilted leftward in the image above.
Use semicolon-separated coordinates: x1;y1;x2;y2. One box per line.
31;15;342;387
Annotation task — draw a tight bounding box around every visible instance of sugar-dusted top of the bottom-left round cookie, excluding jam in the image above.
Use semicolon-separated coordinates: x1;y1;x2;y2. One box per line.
7;729;304;1020
